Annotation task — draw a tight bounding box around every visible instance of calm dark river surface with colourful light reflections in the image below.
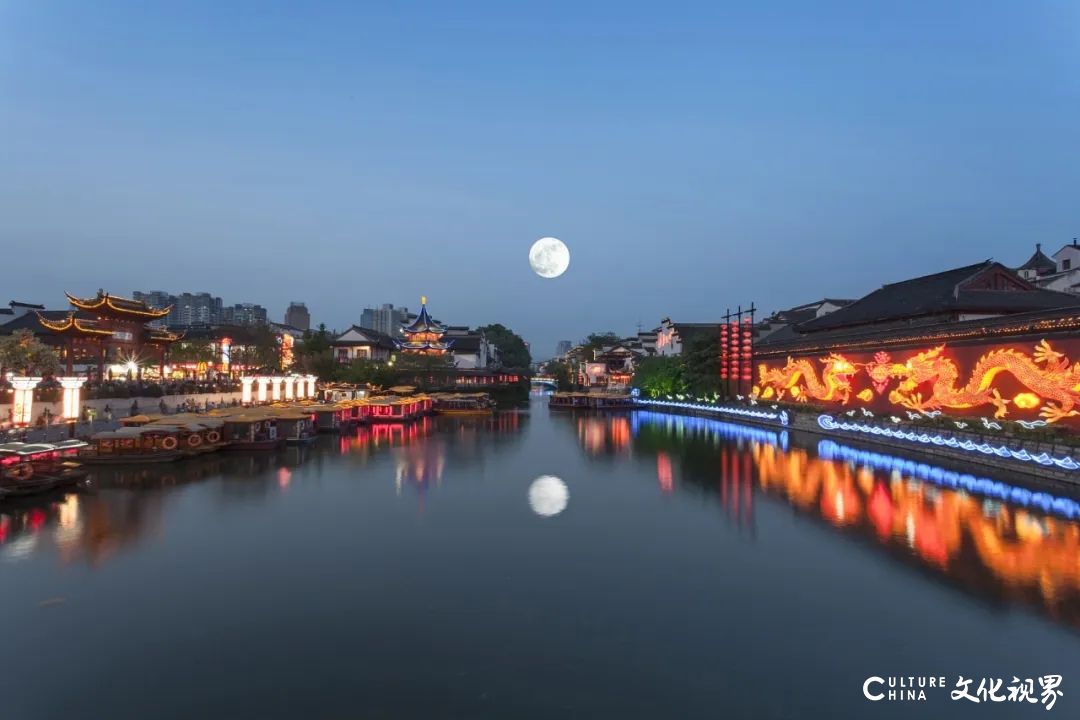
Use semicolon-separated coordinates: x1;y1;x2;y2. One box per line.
0;399;1080;720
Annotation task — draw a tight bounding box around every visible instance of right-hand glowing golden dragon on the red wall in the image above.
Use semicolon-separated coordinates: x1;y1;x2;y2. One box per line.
889;340;1080;422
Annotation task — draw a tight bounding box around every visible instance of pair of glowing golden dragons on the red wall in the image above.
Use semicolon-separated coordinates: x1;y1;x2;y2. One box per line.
754;340;1080;422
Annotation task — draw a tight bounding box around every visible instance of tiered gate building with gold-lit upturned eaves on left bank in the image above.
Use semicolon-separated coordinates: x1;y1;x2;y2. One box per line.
35;290;181;379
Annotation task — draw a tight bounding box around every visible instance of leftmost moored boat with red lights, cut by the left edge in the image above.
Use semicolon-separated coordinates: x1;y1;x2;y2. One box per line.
0;440;86;500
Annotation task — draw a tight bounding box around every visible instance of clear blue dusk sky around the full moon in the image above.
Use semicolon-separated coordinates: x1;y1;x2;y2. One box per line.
0;0;1080;356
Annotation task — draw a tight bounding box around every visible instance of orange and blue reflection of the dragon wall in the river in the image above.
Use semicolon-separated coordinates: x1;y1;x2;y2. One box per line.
626;412;1080;627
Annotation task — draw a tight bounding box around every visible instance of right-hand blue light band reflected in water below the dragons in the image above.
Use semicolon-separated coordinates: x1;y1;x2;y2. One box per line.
818;440;1080;520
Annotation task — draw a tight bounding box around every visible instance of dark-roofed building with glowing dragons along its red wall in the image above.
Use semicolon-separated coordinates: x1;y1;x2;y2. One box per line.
754;260;1080;427
